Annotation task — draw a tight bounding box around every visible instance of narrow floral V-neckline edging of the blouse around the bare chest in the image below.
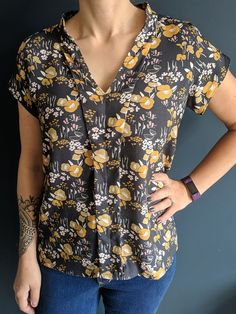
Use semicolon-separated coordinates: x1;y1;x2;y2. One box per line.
62;1;156;95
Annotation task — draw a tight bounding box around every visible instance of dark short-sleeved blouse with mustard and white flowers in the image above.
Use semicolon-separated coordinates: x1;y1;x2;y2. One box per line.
9;2;230;280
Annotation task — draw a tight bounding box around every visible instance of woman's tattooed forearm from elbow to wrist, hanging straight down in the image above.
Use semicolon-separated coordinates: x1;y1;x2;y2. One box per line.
17;156;44;260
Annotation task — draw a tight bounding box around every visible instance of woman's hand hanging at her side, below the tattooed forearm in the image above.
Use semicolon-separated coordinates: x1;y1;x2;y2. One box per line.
13;253;41;314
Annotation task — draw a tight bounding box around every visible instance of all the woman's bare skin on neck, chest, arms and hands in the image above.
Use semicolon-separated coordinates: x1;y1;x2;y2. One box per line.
13;0;236;314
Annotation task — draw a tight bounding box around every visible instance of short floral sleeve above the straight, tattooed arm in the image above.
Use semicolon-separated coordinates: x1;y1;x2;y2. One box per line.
8;41;38;118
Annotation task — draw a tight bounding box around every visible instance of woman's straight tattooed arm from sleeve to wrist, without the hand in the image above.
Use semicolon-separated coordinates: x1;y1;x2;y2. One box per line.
17;103;44;258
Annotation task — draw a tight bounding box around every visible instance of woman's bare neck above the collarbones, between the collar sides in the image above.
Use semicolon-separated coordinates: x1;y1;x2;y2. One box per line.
68;0;145;41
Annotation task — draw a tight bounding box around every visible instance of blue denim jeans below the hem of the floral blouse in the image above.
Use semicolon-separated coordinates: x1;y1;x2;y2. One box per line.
35;253;176;314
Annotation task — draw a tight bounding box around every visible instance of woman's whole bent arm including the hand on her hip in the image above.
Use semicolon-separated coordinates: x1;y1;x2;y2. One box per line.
150;70;236;222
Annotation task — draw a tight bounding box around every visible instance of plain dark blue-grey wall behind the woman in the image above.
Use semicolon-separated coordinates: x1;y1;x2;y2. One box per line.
0;0;236;314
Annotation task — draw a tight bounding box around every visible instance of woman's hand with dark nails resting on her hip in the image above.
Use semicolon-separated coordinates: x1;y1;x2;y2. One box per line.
148;172;192;222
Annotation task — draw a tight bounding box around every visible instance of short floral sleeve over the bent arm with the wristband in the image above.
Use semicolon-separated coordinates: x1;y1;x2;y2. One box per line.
186;22;230;115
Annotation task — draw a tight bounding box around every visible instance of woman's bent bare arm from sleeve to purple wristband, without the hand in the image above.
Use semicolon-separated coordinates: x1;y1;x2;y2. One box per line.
190;70;236;194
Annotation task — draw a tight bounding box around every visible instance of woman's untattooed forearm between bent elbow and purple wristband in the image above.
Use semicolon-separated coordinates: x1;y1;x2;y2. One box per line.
190;130;236;194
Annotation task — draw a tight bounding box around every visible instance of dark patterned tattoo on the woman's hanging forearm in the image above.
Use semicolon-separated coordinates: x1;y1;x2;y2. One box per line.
17;195;41;256
